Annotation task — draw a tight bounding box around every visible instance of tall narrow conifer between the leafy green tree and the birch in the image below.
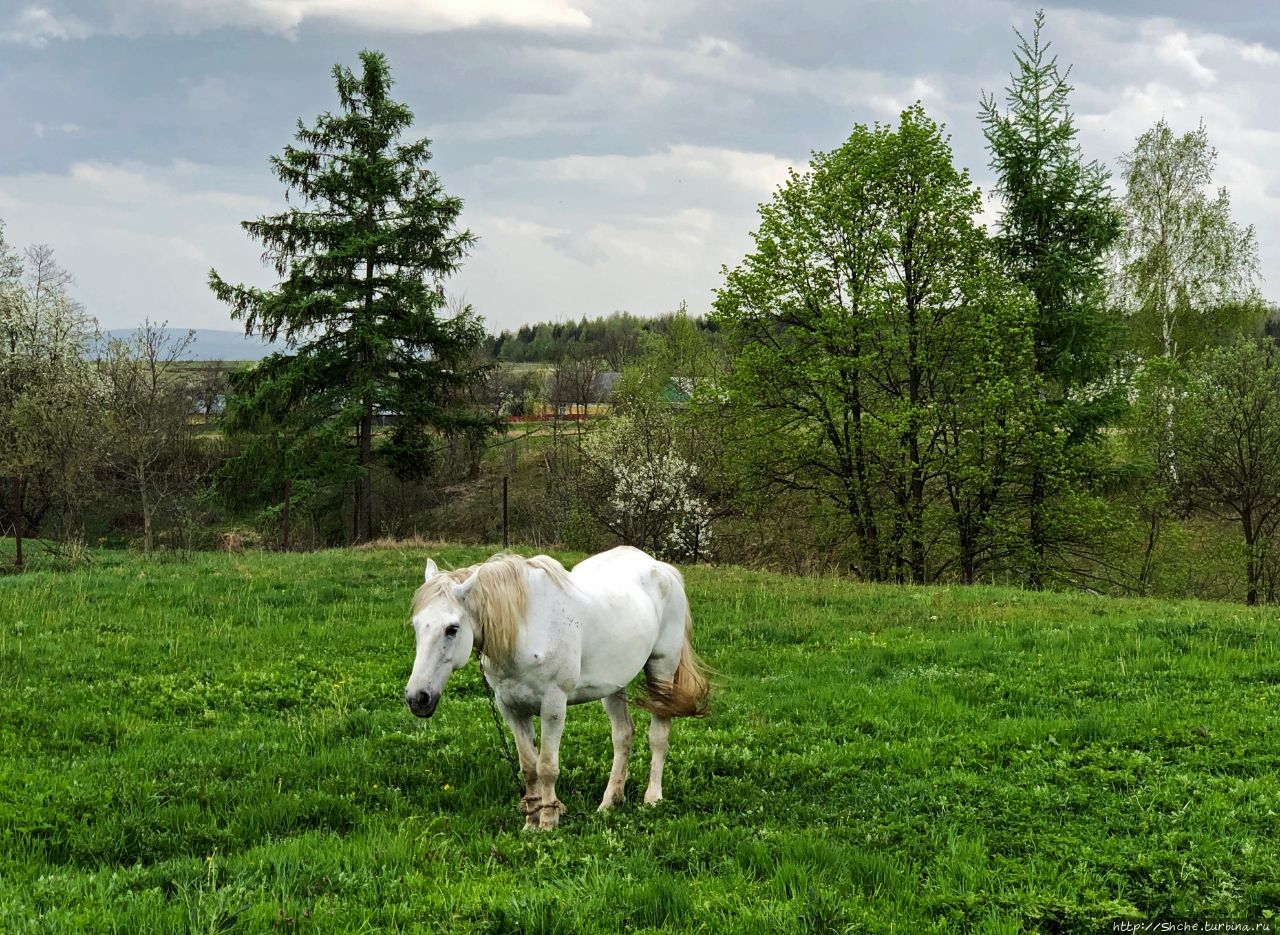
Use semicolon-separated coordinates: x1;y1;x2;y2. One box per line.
980;12;1121;587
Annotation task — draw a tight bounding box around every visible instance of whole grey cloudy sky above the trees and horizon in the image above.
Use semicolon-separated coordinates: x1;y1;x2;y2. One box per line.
0;0;1280;330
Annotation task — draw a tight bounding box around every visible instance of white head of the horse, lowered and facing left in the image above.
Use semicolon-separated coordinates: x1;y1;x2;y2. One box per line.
404;560;475;717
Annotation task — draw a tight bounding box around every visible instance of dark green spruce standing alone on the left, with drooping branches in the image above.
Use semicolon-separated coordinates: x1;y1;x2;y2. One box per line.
210;51;485;542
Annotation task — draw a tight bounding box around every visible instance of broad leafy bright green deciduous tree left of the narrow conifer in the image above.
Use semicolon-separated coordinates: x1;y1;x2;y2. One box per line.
716;105;1037;580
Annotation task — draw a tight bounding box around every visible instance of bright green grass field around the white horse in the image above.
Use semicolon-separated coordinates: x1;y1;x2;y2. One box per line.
0;549;1280;935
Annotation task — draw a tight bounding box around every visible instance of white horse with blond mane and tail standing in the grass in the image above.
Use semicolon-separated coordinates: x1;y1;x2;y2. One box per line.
404;547;708;830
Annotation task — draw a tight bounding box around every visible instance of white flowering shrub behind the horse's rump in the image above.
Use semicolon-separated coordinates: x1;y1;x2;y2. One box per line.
582;416;712;560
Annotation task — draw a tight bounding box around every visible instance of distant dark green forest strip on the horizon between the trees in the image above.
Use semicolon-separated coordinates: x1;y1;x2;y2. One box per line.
484;305;719;370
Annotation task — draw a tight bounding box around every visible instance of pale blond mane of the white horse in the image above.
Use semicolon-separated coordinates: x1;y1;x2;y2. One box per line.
410;552;571;662
